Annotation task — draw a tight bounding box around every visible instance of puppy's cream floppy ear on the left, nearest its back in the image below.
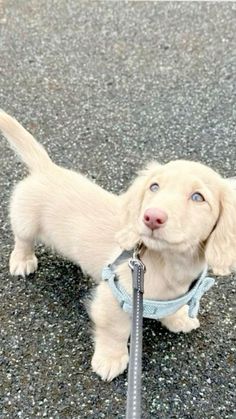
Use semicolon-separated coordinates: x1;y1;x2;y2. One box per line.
116;162;160;250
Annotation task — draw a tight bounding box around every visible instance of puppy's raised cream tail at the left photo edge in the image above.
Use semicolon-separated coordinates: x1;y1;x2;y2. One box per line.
0;110;53;171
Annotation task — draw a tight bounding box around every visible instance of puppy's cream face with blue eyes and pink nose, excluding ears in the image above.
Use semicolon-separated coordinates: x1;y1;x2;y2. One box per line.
137;163;220;251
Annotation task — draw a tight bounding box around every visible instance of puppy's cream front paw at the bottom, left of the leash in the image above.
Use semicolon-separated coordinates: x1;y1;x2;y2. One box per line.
92;351;129;381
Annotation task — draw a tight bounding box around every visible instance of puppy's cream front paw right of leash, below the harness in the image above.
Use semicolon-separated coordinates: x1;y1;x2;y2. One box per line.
161;305;200;333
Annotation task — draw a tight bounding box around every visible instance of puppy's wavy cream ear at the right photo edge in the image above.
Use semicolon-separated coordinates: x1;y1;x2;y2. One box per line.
205;181;236;275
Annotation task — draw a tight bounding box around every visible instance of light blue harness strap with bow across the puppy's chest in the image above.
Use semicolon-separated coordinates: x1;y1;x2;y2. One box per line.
102;264;215;320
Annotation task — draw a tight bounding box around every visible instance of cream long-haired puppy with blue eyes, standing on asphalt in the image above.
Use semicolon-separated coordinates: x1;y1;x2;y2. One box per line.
0;112;236;380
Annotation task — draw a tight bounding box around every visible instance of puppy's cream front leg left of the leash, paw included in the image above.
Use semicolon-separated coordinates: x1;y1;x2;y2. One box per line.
90;282;131;381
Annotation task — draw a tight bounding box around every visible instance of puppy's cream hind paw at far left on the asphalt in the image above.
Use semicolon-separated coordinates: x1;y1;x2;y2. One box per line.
9;250;38;277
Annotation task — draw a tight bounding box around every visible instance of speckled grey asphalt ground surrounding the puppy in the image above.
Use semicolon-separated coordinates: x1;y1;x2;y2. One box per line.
0;0;236;419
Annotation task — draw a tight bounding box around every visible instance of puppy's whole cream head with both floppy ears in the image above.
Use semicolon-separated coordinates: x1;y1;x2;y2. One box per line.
117;160;236;275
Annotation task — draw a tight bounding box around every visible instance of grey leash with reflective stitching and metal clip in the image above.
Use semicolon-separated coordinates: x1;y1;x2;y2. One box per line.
126;245;146;419
